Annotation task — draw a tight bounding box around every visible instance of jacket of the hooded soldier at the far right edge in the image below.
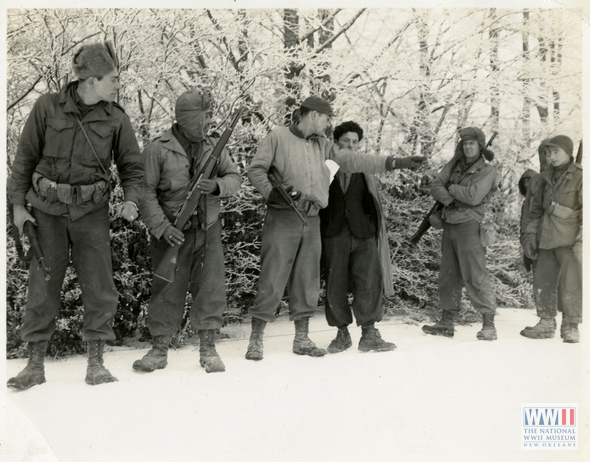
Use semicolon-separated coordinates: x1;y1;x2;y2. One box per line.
524;162;583;249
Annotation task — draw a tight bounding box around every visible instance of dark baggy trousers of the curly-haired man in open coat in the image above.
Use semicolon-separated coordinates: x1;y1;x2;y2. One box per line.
322;223;383;327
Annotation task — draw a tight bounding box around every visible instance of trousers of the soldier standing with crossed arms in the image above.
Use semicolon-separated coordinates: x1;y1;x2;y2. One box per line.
438;220;496;314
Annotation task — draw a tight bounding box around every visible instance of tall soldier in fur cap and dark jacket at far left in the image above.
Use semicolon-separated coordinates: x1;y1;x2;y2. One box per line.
7;43;143;390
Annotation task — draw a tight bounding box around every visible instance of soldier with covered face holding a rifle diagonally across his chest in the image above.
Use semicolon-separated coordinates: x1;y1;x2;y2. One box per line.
133;89;242;372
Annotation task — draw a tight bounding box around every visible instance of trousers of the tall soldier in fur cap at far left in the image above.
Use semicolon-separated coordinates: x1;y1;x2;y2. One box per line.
21;205;119;342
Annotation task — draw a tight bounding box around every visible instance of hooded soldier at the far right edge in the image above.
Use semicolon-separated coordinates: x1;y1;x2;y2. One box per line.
520;135;583;343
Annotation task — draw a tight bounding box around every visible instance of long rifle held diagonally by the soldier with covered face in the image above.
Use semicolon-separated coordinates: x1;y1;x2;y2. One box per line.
154;108;242;282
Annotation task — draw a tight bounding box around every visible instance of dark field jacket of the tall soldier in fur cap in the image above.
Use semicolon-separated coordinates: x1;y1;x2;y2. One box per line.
8;81;143;220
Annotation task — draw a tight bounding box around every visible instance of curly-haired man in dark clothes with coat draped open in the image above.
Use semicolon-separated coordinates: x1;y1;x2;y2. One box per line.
320;121;395;353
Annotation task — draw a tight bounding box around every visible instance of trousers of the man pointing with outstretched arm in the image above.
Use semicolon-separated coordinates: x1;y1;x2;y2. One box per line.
250;207;322;322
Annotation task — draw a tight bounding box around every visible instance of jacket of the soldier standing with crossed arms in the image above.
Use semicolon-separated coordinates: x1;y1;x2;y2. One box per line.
430;155;497;224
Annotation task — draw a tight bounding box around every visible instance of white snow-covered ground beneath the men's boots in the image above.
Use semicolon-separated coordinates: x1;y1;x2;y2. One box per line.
0;309;590;462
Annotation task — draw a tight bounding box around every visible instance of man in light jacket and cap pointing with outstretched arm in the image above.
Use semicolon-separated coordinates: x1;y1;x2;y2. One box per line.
246;96;425;360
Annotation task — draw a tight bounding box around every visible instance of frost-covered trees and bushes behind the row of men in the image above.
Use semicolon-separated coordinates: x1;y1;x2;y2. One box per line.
6;8;582;356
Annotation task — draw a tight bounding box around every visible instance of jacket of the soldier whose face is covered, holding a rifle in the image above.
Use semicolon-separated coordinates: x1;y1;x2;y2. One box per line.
139;129;242;239
